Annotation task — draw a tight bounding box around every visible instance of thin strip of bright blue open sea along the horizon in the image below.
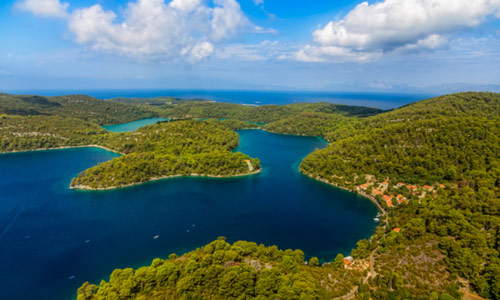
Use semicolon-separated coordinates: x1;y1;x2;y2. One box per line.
4;89;437;109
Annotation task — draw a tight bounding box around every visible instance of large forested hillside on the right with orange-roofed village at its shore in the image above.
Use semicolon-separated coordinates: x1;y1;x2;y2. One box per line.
301;93;500;299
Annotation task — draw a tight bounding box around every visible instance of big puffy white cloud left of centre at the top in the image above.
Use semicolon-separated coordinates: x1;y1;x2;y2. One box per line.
68;0;257;63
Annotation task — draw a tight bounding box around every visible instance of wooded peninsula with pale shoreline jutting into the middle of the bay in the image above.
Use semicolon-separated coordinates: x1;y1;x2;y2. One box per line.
71;120;260;189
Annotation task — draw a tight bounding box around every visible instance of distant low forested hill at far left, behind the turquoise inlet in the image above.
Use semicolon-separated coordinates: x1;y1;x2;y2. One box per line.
0;94;158;125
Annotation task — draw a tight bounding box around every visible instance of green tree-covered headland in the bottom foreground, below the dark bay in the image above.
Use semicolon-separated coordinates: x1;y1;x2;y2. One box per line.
77;238;362;300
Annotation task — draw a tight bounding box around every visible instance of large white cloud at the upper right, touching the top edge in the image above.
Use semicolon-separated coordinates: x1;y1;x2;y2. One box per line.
296;0;500;61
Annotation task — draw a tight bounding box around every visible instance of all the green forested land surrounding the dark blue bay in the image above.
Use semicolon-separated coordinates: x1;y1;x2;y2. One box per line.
0;92;500;300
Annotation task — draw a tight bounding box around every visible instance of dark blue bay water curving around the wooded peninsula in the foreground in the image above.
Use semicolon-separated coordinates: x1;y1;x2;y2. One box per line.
0;130;377;300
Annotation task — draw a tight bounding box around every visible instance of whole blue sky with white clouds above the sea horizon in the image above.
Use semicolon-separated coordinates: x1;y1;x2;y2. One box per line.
0;0;500;92
